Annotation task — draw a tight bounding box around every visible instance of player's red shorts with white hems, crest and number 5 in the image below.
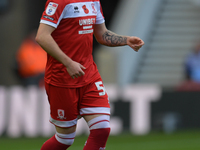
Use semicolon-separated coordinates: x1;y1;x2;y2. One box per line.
45;78;110;127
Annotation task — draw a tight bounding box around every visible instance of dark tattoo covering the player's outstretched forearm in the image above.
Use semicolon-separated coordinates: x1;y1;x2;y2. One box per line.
103;31;127;46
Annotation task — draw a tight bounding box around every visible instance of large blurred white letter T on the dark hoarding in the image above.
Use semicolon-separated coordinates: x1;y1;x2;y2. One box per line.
123;85;161;134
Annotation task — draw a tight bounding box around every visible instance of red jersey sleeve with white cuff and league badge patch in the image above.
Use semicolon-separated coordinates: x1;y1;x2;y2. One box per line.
40;0;65;28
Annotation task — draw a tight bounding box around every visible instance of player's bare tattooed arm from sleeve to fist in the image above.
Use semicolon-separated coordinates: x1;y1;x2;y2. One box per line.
94;23;144;51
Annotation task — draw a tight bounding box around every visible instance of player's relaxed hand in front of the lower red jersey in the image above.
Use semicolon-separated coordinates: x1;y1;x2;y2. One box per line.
66;61;86;79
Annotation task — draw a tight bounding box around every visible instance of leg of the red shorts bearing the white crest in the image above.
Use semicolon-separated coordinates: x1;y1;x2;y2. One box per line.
45;84;79;128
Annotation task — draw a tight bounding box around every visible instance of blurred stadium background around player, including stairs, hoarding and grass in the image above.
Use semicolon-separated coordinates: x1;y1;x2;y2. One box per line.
0;0;200;150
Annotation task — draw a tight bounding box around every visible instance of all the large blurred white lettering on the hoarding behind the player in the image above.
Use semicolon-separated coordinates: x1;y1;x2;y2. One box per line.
0;85;161;137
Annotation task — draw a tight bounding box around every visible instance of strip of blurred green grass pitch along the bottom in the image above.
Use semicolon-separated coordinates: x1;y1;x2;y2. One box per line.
0;130;200;150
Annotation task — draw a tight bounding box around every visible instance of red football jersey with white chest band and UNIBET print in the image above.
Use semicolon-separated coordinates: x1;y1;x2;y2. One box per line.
40;0;105;88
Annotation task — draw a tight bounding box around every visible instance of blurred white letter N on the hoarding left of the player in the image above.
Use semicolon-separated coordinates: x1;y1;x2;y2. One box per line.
7;87;39;137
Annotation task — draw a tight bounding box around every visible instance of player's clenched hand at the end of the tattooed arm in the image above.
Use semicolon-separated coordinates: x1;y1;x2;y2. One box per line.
127;36;144;52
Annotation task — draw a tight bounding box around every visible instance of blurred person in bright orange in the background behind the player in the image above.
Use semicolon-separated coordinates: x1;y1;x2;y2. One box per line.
14;30;47;87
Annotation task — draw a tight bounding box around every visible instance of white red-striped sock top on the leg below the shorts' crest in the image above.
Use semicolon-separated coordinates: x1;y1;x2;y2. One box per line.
55;132;76;145
